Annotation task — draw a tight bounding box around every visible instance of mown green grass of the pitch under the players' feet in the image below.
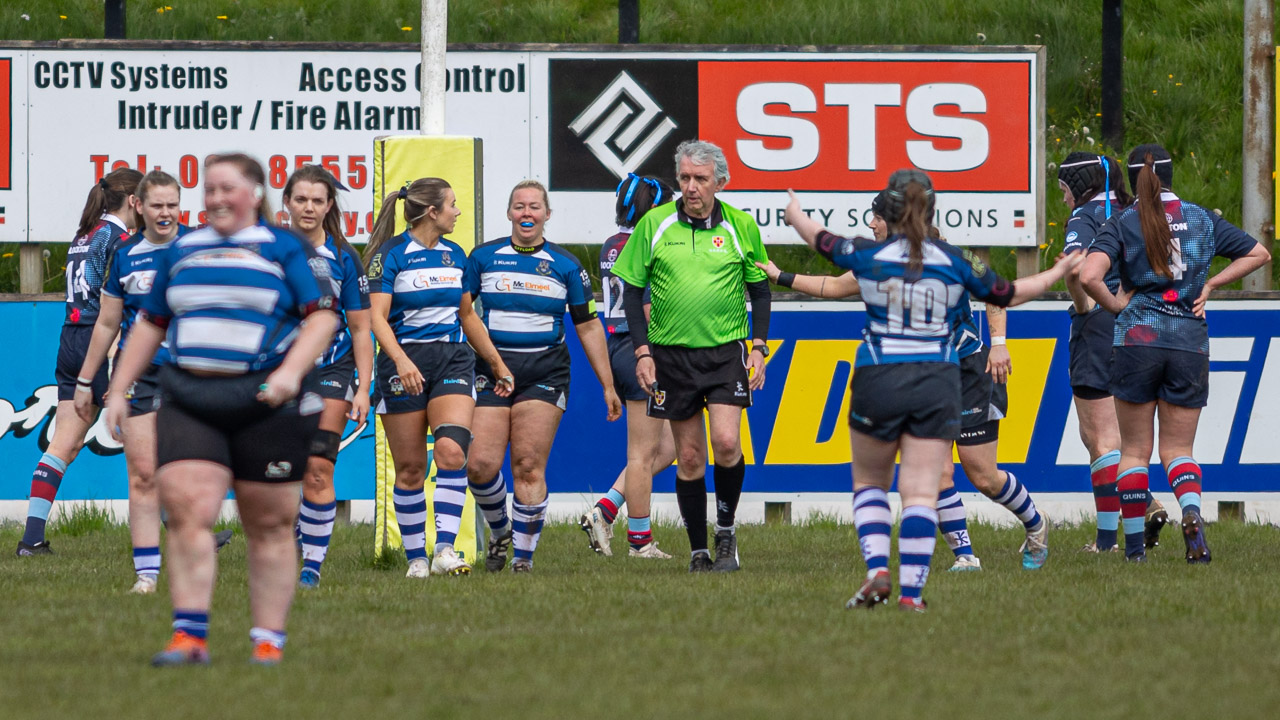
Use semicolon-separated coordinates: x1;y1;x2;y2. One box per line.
0;520;1280;720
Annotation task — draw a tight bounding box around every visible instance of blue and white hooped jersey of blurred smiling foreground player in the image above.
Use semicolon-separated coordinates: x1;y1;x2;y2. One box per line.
141;225;338;373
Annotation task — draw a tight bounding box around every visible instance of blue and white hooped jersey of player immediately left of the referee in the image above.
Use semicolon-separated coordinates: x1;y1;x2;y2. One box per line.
468;237;596;352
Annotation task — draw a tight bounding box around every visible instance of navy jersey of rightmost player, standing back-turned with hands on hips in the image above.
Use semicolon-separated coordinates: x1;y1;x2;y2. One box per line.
1089;191;1257;355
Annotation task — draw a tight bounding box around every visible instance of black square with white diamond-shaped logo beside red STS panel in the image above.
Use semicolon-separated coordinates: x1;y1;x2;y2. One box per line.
549;59;698;192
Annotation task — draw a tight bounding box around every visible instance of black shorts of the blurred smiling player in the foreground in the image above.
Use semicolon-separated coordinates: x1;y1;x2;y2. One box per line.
156;365;324;483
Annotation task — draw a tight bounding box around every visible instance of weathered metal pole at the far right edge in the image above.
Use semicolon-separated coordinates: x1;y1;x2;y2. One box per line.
1240;0;1276;290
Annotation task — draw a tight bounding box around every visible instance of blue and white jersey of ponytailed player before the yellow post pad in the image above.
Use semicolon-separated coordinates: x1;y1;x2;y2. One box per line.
369;232;470;345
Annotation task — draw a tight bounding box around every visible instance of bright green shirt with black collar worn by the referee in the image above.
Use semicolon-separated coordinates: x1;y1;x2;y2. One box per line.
613;200;769;347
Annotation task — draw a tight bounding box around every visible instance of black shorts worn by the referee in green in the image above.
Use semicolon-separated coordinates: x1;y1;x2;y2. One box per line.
648;340;751;420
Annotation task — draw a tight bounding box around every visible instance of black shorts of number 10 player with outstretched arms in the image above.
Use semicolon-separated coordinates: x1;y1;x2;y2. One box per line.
849;363;960;442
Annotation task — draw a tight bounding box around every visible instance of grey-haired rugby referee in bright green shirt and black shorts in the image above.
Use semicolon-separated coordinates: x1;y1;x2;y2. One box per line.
613;140;769;573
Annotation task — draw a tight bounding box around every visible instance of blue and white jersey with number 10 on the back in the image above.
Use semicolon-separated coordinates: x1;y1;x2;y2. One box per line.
817;231;1014;368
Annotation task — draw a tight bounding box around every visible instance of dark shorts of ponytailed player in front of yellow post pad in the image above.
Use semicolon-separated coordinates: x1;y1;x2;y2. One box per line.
374;342;476;415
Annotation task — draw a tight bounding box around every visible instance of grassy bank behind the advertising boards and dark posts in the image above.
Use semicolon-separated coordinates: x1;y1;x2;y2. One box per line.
0;0;1280;292
